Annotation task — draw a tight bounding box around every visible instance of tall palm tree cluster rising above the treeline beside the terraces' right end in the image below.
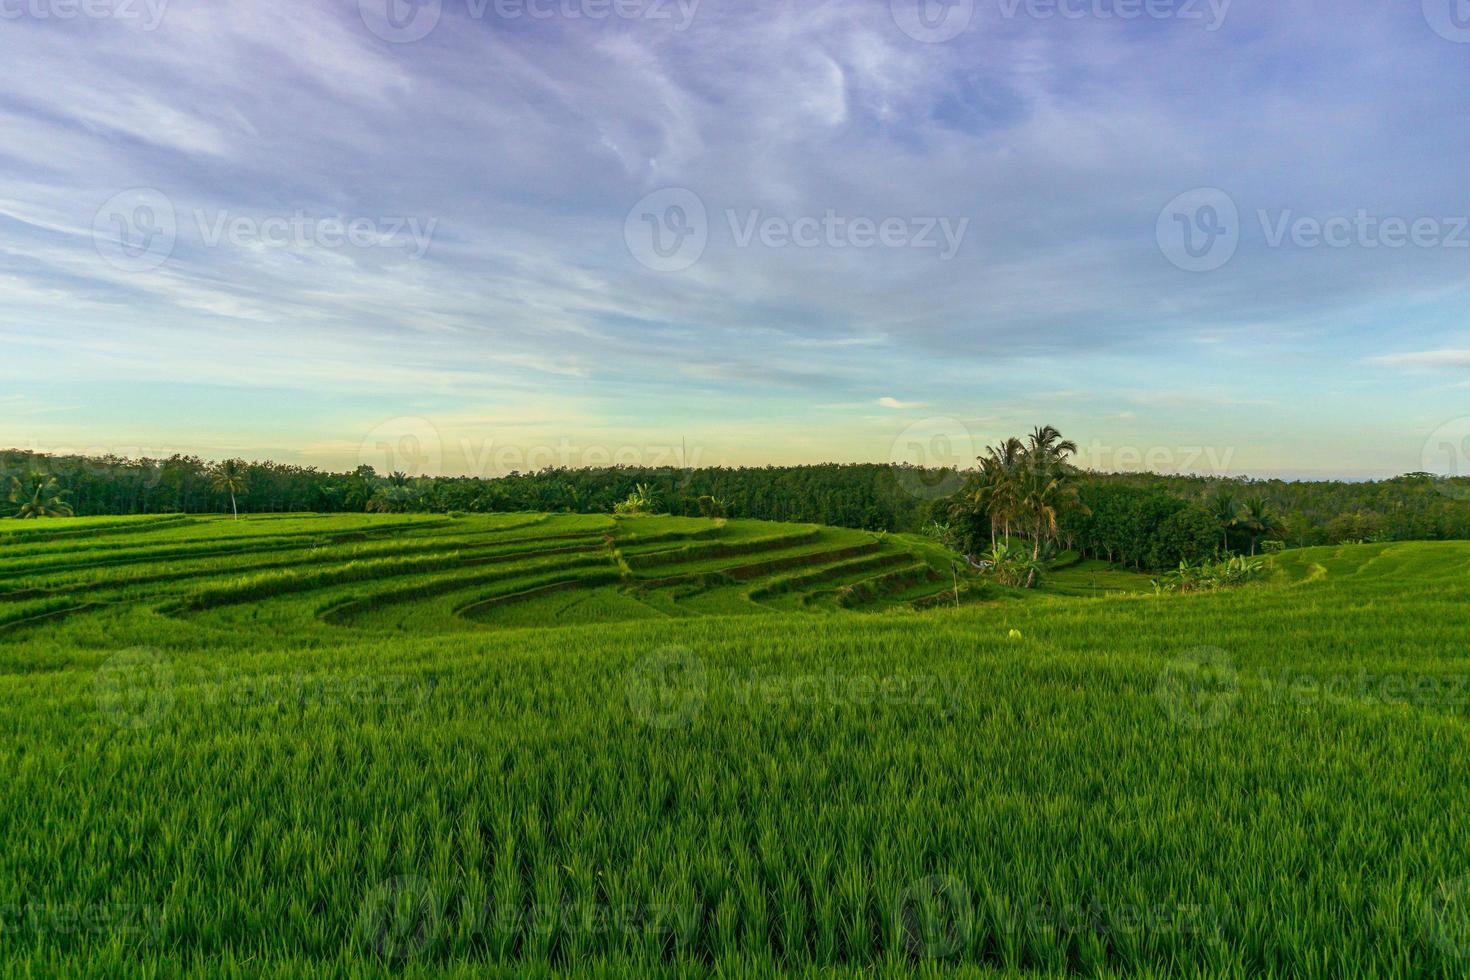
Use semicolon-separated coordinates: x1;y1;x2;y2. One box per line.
969;426;1082;588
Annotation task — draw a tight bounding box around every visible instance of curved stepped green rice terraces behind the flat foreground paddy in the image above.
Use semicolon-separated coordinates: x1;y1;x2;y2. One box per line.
0;514;970;643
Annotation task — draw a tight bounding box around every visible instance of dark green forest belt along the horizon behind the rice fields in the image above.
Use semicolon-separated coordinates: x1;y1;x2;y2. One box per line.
0;441;1470;569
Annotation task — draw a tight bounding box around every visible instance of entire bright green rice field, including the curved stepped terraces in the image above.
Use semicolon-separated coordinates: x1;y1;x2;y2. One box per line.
0;514;1470;977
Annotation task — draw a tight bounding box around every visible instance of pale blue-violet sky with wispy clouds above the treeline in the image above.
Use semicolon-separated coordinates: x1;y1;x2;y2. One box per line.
0;0;1470;479
